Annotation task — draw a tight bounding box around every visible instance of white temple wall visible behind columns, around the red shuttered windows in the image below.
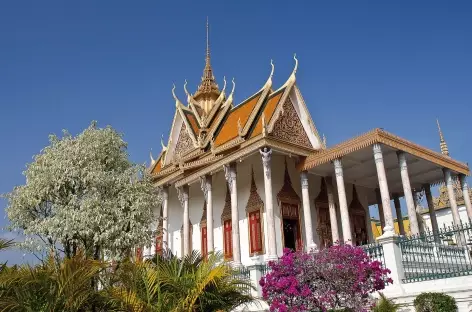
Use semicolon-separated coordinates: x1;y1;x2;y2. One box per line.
162;153;371;266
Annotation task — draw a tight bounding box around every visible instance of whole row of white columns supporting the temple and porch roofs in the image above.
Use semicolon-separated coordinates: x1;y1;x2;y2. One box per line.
162;144;472;266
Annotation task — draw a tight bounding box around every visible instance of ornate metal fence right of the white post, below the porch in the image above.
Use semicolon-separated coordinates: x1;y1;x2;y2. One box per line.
399;221;472;283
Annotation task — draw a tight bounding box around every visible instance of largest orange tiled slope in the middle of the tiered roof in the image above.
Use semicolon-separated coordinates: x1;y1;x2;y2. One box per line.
215;92;262;146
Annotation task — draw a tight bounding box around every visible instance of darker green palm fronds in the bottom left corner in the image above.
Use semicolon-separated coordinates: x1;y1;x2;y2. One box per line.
0;254;109;312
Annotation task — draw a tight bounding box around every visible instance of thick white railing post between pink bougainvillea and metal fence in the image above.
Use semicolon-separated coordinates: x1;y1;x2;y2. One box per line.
377;235;405;285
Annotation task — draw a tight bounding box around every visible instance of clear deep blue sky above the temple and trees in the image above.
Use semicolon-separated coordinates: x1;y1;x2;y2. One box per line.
0;0;472;263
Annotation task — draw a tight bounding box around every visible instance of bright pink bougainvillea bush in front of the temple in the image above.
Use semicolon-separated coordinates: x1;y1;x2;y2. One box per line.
259;245;391;312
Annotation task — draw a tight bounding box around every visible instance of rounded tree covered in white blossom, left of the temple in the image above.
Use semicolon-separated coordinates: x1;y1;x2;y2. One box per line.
6;122;160;259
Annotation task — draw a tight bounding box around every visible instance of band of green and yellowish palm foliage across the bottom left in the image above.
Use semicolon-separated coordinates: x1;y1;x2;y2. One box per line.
0;252;254;312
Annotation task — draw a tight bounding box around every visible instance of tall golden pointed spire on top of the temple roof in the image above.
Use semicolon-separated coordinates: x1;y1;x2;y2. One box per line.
194;17;220;109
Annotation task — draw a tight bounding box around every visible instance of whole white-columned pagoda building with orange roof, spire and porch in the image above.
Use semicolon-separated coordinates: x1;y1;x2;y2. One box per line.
147;23;472;266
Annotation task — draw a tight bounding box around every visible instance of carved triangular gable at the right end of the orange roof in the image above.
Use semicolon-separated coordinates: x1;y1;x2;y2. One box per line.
271;97;312;148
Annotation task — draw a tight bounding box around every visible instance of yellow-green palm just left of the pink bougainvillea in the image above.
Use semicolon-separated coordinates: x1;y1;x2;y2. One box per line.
109;251;254;312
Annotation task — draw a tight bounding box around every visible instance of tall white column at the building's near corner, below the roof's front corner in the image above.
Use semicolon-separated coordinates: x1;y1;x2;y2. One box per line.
259;147;277;261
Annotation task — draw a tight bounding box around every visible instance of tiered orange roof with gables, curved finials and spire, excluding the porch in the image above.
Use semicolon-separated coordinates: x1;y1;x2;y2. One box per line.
150;31;324;185
